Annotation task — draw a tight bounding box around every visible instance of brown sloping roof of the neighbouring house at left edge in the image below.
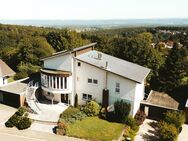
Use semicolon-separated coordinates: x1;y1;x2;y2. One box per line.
0;59;15;77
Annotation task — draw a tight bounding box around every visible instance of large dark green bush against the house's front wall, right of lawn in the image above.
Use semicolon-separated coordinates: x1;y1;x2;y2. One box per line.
114;100;131;122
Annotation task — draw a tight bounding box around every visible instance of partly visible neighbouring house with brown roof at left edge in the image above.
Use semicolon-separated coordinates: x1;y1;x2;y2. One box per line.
0;59;15;87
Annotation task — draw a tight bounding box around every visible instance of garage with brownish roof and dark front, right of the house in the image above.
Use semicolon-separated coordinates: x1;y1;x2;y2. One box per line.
140;90;179;120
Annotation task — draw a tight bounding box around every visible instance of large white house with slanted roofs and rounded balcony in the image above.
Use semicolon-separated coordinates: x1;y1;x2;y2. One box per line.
41;43;150;116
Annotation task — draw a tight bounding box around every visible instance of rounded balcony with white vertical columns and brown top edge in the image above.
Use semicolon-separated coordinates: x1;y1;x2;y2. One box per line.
41;69;72;94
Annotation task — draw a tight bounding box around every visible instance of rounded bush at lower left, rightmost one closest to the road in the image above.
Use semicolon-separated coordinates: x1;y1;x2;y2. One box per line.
16;117;31;130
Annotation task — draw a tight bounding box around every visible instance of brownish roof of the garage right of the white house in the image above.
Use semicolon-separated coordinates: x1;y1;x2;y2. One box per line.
144;90;179;110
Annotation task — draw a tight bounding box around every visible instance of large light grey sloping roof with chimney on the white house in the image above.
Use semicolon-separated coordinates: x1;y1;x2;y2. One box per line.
75;50;150;83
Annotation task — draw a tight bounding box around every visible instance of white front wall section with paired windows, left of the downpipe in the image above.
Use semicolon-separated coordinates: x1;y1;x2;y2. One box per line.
75;61;105;104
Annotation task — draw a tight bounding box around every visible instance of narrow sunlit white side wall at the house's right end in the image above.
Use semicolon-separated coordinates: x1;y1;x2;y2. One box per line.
133;82;144;116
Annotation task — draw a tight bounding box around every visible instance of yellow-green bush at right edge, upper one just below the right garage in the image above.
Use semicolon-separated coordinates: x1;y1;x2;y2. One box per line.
164;111;185;130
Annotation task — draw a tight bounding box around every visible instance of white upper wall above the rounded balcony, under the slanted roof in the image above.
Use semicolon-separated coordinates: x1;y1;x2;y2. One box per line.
44;54;72;71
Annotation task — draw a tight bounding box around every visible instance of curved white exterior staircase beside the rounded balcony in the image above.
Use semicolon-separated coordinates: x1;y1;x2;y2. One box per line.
25;81;41;114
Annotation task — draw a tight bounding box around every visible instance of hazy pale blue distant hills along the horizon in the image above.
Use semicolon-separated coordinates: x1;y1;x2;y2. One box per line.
0;19;188;28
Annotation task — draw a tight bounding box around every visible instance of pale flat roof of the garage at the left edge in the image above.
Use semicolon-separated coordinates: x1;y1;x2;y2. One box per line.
0;82;27;95
